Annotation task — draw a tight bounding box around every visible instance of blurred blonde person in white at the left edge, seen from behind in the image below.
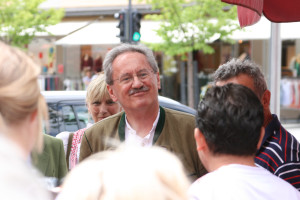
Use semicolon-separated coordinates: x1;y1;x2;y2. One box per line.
0;43;49;200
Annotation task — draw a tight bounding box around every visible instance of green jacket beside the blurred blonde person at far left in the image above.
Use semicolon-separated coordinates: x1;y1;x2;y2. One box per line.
32;134;68;180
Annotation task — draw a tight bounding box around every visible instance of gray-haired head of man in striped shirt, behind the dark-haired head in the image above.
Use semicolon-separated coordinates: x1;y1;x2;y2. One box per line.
214;59;271;125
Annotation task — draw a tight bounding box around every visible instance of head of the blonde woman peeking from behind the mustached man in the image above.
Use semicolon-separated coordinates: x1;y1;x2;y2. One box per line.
86;73;121;123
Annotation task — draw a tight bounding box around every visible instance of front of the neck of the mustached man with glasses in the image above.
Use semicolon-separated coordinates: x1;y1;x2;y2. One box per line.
125;106;159;138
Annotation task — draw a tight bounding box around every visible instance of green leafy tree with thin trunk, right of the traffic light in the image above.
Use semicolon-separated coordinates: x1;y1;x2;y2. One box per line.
142;0;239;107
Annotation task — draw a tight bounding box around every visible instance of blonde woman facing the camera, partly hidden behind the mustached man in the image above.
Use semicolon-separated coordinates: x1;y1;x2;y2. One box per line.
56;73;122;169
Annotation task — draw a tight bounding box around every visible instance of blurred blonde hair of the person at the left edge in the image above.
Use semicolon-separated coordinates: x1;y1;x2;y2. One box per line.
0;42;48;151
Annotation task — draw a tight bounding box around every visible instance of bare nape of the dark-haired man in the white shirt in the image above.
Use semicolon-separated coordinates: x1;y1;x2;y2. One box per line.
206;155;255;172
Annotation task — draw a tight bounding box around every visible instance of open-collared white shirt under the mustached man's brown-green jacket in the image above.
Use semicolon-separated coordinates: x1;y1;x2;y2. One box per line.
125;109;160;147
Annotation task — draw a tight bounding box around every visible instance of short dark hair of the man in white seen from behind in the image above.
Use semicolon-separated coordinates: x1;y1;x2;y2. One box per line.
196;83;264;156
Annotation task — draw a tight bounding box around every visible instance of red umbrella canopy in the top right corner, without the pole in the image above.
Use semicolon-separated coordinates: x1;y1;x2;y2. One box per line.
221;0;300;27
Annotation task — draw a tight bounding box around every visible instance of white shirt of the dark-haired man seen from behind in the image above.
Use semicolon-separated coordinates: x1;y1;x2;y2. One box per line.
189;164;300;200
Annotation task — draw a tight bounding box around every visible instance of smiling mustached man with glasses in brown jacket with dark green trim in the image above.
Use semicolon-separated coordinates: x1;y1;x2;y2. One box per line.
80;44;206;180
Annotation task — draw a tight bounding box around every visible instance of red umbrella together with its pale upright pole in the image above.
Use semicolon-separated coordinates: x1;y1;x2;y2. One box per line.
221;0;300;115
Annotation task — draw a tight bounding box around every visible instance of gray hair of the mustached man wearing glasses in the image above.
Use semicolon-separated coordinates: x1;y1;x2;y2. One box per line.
103;44;158;85
